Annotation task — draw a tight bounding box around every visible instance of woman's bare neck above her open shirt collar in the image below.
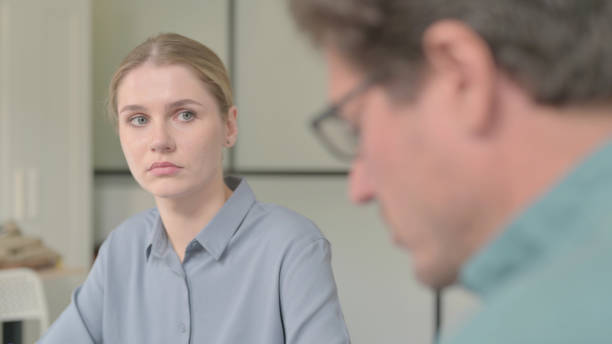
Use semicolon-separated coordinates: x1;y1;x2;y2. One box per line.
155;178;232;262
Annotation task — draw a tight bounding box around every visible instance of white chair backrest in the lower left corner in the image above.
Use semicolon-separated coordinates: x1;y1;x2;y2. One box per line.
0;268;49;335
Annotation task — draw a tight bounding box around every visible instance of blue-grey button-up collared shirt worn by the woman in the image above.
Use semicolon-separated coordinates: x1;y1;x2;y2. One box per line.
40;177;350;344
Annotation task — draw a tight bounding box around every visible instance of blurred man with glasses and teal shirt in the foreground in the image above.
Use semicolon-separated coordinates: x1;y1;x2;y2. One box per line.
291;0;612;343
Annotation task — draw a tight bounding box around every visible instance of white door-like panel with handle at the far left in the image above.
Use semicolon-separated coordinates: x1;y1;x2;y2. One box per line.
0;0;93;267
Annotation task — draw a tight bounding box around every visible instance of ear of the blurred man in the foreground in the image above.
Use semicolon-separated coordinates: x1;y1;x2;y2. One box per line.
423;19;497;133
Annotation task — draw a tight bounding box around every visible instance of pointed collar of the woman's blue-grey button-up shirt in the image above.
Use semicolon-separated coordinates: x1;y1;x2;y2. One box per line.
145;176;255;260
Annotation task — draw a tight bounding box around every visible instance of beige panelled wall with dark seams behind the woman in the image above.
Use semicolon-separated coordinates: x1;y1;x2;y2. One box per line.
93;0;475;344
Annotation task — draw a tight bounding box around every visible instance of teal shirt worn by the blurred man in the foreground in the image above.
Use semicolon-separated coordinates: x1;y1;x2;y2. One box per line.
442;138;612;344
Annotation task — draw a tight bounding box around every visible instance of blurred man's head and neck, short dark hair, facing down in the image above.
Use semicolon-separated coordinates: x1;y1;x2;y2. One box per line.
291;0;612;287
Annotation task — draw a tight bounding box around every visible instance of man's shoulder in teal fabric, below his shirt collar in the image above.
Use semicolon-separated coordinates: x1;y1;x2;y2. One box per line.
442;237;612;344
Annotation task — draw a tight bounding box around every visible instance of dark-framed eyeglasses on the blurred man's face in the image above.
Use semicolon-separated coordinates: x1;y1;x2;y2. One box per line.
310;78;376;161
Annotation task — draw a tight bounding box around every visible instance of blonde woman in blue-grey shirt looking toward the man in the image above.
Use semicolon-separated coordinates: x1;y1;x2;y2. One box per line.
41;34;349;344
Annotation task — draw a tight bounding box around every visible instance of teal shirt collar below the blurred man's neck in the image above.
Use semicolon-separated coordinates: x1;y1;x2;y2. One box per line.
459;141;612;298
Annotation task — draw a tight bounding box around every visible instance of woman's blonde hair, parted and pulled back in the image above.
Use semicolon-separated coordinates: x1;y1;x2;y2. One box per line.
107;33;234;123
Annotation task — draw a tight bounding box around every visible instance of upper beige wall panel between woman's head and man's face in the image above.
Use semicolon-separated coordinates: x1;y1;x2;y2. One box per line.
235;0;346;170
